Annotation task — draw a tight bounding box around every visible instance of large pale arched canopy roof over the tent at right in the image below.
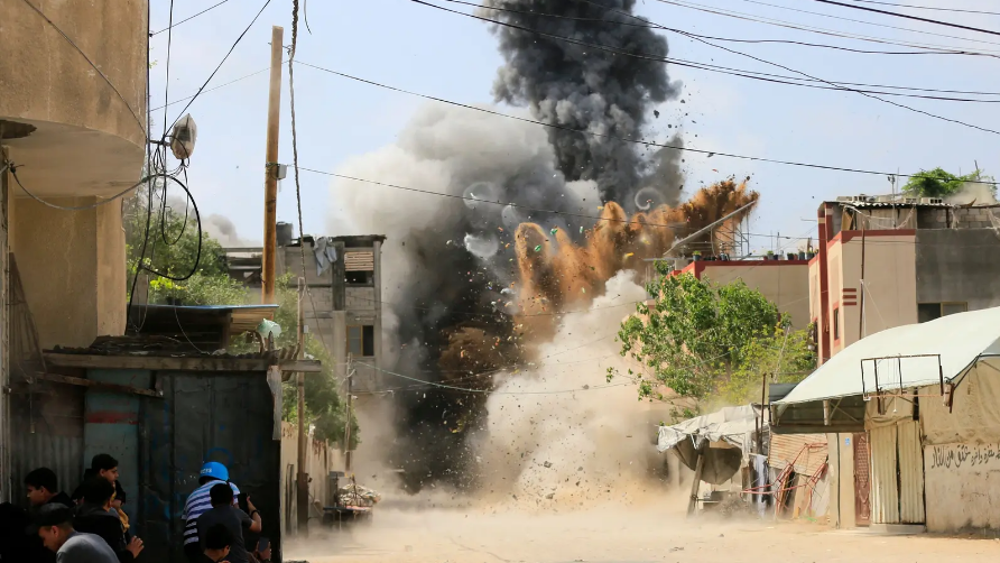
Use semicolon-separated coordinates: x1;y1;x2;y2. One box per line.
775;307;1000;405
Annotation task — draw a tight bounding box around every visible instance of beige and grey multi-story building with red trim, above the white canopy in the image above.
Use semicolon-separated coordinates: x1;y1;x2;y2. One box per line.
809;196;1000;362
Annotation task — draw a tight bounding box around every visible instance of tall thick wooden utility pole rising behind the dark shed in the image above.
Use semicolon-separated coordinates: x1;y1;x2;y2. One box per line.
261;26;285;305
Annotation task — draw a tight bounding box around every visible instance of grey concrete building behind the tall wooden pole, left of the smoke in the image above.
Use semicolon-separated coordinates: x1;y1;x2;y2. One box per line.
226;231;385;393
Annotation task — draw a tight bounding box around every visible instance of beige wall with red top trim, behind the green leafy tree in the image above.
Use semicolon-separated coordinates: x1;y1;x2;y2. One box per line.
696;260;811;329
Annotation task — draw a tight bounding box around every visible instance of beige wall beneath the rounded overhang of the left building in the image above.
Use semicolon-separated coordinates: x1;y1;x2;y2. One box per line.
10;198;126;348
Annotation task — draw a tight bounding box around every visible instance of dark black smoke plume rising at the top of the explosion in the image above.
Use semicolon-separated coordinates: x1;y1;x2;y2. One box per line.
482;0;680;210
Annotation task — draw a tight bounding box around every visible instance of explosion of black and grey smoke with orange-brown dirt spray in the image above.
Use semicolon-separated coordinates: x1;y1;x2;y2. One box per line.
331;0;757;490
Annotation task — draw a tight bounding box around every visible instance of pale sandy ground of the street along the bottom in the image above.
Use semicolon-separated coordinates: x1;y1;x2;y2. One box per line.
285;503;1000;563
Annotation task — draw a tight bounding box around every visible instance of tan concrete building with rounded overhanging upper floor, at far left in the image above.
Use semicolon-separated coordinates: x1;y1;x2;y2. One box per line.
0;0;148;500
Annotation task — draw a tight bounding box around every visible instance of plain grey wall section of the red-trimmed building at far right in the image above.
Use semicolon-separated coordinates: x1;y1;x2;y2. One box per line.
916;231;1000;311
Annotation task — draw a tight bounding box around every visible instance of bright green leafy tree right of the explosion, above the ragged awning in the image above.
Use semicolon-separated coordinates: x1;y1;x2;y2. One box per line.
608;264;815;414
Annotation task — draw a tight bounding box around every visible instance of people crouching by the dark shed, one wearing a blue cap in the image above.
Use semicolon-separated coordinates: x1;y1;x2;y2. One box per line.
0;454;271;563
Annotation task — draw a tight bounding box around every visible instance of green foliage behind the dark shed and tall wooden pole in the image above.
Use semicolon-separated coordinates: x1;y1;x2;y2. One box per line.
125;190;360;449
